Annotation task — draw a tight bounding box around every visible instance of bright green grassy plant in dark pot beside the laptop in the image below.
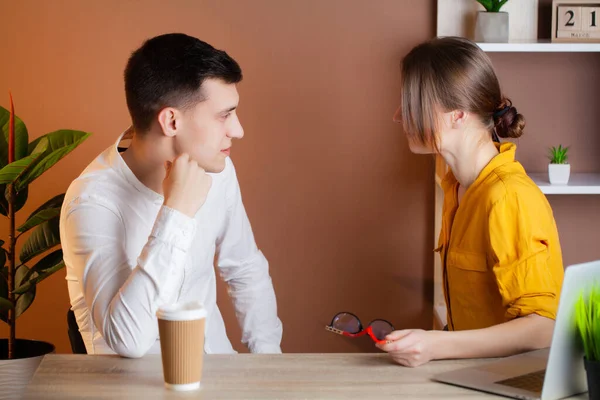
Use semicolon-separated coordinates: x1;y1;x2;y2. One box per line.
575;286;600;400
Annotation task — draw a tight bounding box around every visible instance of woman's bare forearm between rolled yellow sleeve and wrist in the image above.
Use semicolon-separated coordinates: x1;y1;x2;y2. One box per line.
434;314;554;359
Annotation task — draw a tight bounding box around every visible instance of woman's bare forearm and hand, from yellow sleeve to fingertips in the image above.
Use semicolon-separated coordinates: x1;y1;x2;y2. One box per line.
377;314;554;367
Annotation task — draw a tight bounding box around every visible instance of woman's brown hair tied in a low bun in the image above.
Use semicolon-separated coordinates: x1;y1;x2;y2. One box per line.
401;37;525;148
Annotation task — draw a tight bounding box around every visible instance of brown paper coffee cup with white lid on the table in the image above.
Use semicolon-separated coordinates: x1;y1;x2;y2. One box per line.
156;302;206;391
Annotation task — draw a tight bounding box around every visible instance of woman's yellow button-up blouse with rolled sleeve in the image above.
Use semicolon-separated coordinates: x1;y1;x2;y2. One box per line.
437;143;564;330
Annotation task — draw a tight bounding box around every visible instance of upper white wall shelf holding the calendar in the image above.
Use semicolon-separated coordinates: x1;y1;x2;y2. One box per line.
477;40;600;53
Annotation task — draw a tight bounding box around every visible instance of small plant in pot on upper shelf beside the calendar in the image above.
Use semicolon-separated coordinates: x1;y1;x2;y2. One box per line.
475;0;508;43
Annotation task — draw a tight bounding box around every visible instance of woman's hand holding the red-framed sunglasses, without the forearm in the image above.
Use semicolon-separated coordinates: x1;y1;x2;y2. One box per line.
376;329;447;367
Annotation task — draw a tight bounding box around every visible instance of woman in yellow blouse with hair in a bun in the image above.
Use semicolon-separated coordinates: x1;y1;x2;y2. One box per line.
378;37;563;366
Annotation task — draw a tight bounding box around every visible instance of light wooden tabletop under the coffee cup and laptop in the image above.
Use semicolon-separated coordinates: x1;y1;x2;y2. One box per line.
25;354;586;400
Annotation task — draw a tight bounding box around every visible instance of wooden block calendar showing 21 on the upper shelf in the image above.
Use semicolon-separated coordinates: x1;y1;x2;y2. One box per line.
551;0;600;42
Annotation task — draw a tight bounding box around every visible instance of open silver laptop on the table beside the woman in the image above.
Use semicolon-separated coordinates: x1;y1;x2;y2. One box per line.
433;260;600;400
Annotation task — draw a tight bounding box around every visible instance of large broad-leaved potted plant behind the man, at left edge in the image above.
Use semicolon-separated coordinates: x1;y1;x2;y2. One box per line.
0;92;90;398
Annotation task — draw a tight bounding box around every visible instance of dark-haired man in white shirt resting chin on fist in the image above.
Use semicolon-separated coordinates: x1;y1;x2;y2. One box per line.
60;34;282;357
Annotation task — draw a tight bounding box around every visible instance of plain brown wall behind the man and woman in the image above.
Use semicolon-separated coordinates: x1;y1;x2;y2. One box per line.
0;0;600;352
